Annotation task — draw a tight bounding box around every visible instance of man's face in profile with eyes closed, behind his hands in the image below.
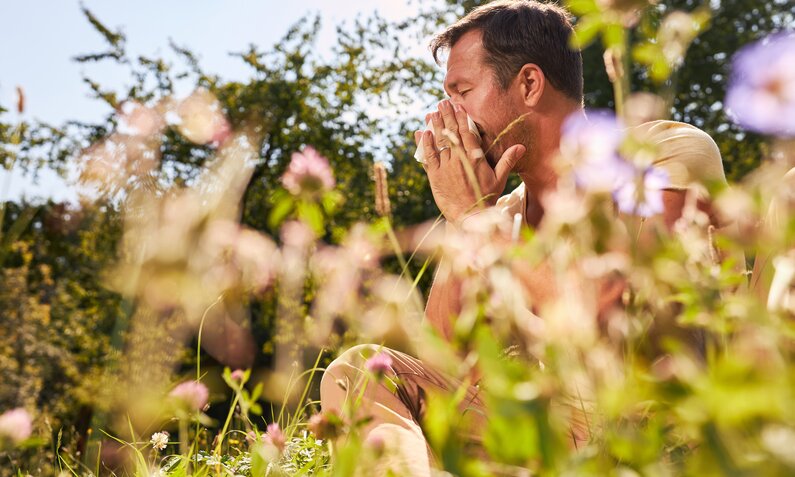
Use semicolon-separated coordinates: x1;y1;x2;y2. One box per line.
444;30;530;167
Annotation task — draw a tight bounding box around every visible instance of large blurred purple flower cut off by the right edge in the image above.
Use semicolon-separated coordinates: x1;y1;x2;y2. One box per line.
726;32;795;136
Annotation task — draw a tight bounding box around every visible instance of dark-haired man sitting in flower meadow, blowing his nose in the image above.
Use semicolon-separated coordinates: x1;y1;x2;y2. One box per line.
321;0;725;475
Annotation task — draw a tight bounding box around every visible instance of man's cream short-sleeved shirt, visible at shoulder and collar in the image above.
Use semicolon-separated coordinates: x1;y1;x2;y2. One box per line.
495;121;726;217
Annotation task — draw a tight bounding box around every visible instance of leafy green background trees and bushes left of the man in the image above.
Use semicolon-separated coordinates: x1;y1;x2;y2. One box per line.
0;10;448;468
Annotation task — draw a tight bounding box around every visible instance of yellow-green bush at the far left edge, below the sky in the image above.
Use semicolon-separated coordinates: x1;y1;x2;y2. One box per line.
0;203;121;475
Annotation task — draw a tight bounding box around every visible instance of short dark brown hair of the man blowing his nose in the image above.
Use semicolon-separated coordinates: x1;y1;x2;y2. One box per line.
431;0;583;103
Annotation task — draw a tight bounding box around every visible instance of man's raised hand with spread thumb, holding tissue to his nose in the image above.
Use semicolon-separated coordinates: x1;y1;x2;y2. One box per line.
414;100;525;223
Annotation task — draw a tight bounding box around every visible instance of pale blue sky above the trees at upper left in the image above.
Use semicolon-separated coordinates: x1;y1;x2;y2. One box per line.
0;0;432;200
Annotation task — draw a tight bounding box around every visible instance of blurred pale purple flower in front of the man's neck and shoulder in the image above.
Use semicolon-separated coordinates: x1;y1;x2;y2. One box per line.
560;111;634;192
